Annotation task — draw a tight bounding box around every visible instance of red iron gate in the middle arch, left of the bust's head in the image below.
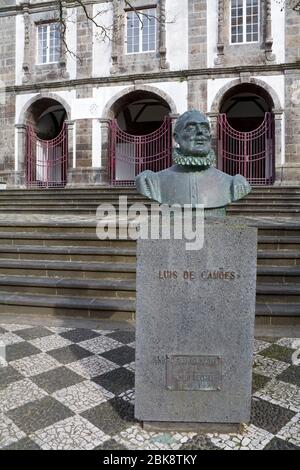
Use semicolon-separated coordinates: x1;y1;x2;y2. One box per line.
108;117;172;186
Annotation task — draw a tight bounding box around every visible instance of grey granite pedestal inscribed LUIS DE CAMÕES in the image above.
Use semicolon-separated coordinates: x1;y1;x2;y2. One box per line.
135;219;257;429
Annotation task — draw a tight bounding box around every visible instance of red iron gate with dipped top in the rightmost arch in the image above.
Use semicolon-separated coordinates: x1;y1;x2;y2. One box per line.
218;113;275;185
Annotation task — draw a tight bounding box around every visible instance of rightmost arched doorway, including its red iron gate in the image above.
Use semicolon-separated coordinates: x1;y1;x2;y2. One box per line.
218;83;275;185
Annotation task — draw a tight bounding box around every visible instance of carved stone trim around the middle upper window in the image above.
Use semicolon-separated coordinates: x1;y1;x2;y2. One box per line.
111;0;169;74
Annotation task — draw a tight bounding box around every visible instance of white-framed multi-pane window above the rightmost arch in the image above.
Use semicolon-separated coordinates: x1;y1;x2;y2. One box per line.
231;0;259;44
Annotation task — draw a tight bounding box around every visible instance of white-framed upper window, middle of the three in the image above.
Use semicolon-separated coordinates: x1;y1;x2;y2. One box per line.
127;8;156;54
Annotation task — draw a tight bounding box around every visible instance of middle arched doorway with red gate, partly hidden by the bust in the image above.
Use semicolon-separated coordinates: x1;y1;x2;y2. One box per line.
108;90;172;186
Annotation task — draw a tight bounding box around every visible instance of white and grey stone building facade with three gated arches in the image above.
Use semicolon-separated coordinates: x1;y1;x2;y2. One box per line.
0;0;300;188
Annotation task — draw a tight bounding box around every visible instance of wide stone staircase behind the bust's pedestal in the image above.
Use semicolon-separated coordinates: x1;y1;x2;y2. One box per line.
0;187;300;324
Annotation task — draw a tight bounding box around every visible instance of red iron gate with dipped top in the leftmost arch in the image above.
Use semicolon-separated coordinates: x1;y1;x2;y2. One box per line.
26;124;68;188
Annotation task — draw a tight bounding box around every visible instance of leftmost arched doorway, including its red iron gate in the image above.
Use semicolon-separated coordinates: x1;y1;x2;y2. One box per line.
25;98;68;188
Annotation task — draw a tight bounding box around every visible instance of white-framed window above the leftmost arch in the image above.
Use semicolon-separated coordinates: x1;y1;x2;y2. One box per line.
37;23;61;64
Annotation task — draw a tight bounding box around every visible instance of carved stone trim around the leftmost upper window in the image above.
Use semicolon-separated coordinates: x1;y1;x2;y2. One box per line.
23;4;69;84
